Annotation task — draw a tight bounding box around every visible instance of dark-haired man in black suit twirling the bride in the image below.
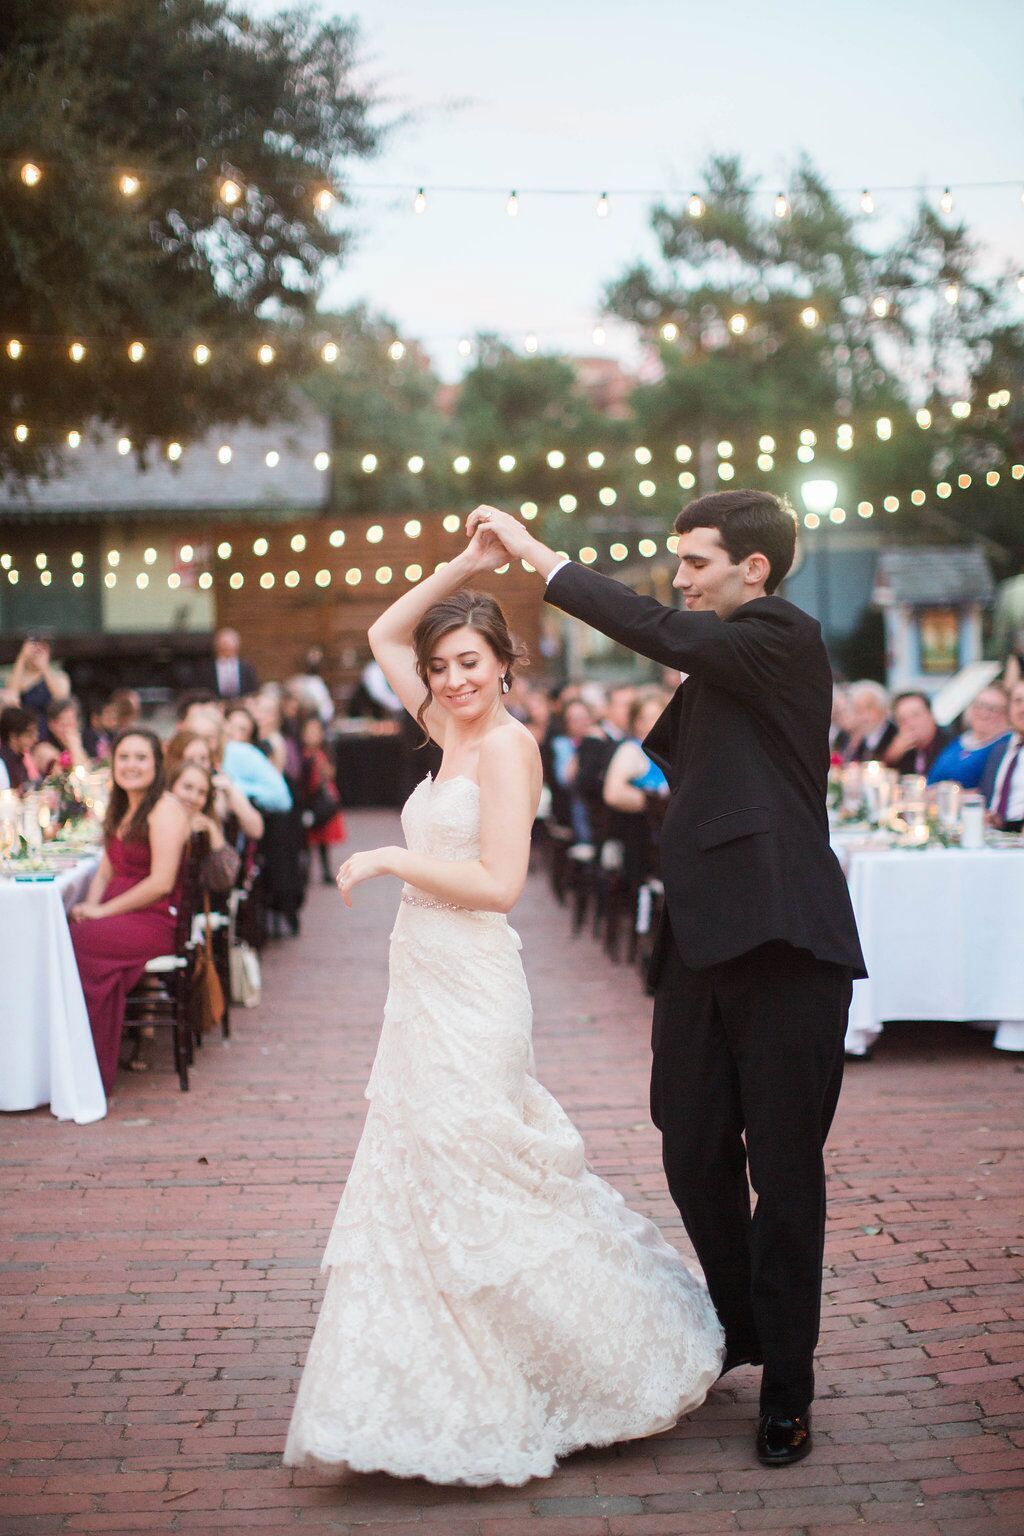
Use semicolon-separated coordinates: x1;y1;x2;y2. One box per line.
467;490;866;1465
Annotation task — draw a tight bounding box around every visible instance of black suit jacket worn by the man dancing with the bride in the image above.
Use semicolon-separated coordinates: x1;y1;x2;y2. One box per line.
545;564;866;977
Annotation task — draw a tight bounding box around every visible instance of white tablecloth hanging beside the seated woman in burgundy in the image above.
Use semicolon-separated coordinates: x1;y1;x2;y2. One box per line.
0;857;106;1126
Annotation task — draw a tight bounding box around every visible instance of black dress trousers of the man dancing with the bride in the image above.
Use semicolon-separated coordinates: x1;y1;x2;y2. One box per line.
651;921;852;1415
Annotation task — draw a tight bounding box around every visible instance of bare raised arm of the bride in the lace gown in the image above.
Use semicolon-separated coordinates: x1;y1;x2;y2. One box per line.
367;516;508;746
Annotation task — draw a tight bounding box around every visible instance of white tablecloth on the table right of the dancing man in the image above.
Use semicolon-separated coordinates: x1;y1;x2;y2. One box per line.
837;845;1024;1054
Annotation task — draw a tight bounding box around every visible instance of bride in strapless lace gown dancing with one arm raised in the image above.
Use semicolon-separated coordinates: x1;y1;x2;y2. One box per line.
284;527;723;1485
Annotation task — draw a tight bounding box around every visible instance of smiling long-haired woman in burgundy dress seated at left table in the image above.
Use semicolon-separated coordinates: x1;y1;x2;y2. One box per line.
71;727;189;1094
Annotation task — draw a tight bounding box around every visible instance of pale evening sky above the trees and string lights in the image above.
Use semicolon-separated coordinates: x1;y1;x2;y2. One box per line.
249;0;1024;376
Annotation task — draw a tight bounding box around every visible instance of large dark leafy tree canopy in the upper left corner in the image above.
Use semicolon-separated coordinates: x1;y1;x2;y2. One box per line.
0;0;384;475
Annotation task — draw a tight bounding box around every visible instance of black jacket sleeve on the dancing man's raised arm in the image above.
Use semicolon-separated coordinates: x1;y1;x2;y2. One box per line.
543;561;809;694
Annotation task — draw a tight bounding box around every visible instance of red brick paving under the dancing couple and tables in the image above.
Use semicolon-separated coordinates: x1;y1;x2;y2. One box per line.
0;813;1024;1536
